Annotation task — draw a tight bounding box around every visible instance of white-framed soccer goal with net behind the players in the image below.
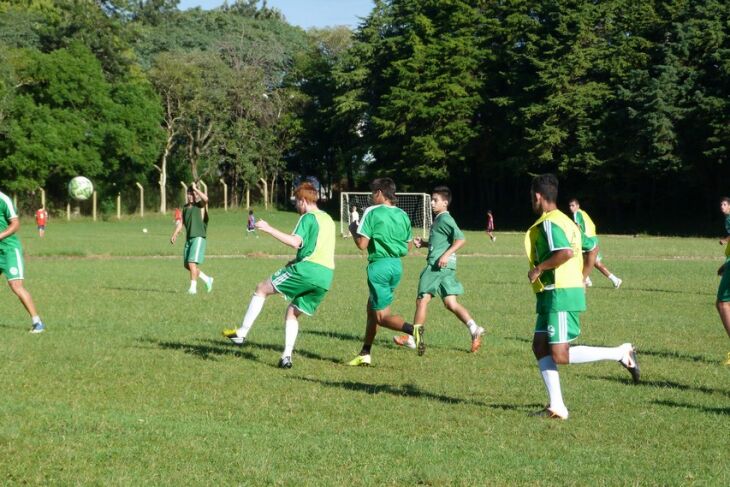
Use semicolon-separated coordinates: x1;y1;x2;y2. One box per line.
340;192;433;238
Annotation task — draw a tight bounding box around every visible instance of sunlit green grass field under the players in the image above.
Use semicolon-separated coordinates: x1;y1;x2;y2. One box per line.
0;211;730;485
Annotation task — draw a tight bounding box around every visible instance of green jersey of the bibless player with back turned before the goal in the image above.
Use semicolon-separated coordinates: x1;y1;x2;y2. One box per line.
357;205;411;262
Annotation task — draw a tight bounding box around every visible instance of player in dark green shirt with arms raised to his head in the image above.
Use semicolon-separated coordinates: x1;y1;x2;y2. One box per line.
170;182;213;294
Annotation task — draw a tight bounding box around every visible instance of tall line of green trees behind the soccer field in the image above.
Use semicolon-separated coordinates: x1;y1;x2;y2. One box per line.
0;0;730;233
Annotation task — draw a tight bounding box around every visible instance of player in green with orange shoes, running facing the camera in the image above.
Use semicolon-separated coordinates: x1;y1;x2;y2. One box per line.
393;186;484;353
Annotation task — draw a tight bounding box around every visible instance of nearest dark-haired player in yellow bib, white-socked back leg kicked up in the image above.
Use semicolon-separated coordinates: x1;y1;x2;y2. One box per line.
525;174;639;419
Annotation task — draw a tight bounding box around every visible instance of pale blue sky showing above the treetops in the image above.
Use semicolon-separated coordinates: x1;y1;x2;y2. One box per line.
173;0;373;29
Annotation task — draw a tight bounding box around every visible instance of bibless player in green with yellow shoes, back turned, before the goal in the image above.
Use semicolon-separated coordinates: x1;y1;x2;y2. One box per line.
348;178;426;366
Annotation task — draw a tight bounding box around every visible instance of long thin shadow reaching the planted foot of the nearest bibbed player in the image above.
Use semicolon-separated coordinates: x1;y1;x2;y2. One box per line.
293;377;542;411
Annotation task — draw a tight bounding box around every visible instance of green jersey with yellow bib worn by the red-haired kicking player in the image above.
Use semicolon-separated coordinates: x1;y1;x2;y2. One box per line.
293;210;335;289
